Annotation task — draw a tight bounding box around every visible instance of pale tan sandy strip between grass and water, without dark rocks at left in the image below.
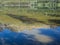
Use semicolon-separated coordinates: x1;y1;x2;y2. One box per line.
8;24;50;32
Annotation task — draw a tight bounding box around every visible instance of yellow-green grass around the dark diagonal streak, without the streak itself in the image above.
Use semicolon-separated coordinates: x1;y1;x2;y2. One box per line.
0;0;60;25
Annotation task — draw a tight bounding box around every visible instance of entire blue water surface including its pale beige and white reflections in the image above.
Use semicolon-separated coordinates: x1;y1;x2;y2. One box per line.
0;27;60;45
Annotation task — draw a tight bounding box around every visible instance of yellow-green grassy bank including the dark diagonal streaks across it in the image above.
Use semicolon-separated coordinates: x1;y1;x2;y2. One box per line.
0;0;60;26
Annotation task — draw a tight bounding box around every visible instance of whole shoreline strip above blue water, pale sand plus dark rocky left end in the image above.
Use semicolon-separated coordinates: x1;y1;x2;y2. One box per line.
0;23;57;32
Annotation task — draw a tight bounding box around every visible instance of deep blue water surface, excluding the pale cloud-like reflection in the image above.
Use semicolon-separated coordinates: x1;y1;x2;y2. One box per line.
0;27;60;45
